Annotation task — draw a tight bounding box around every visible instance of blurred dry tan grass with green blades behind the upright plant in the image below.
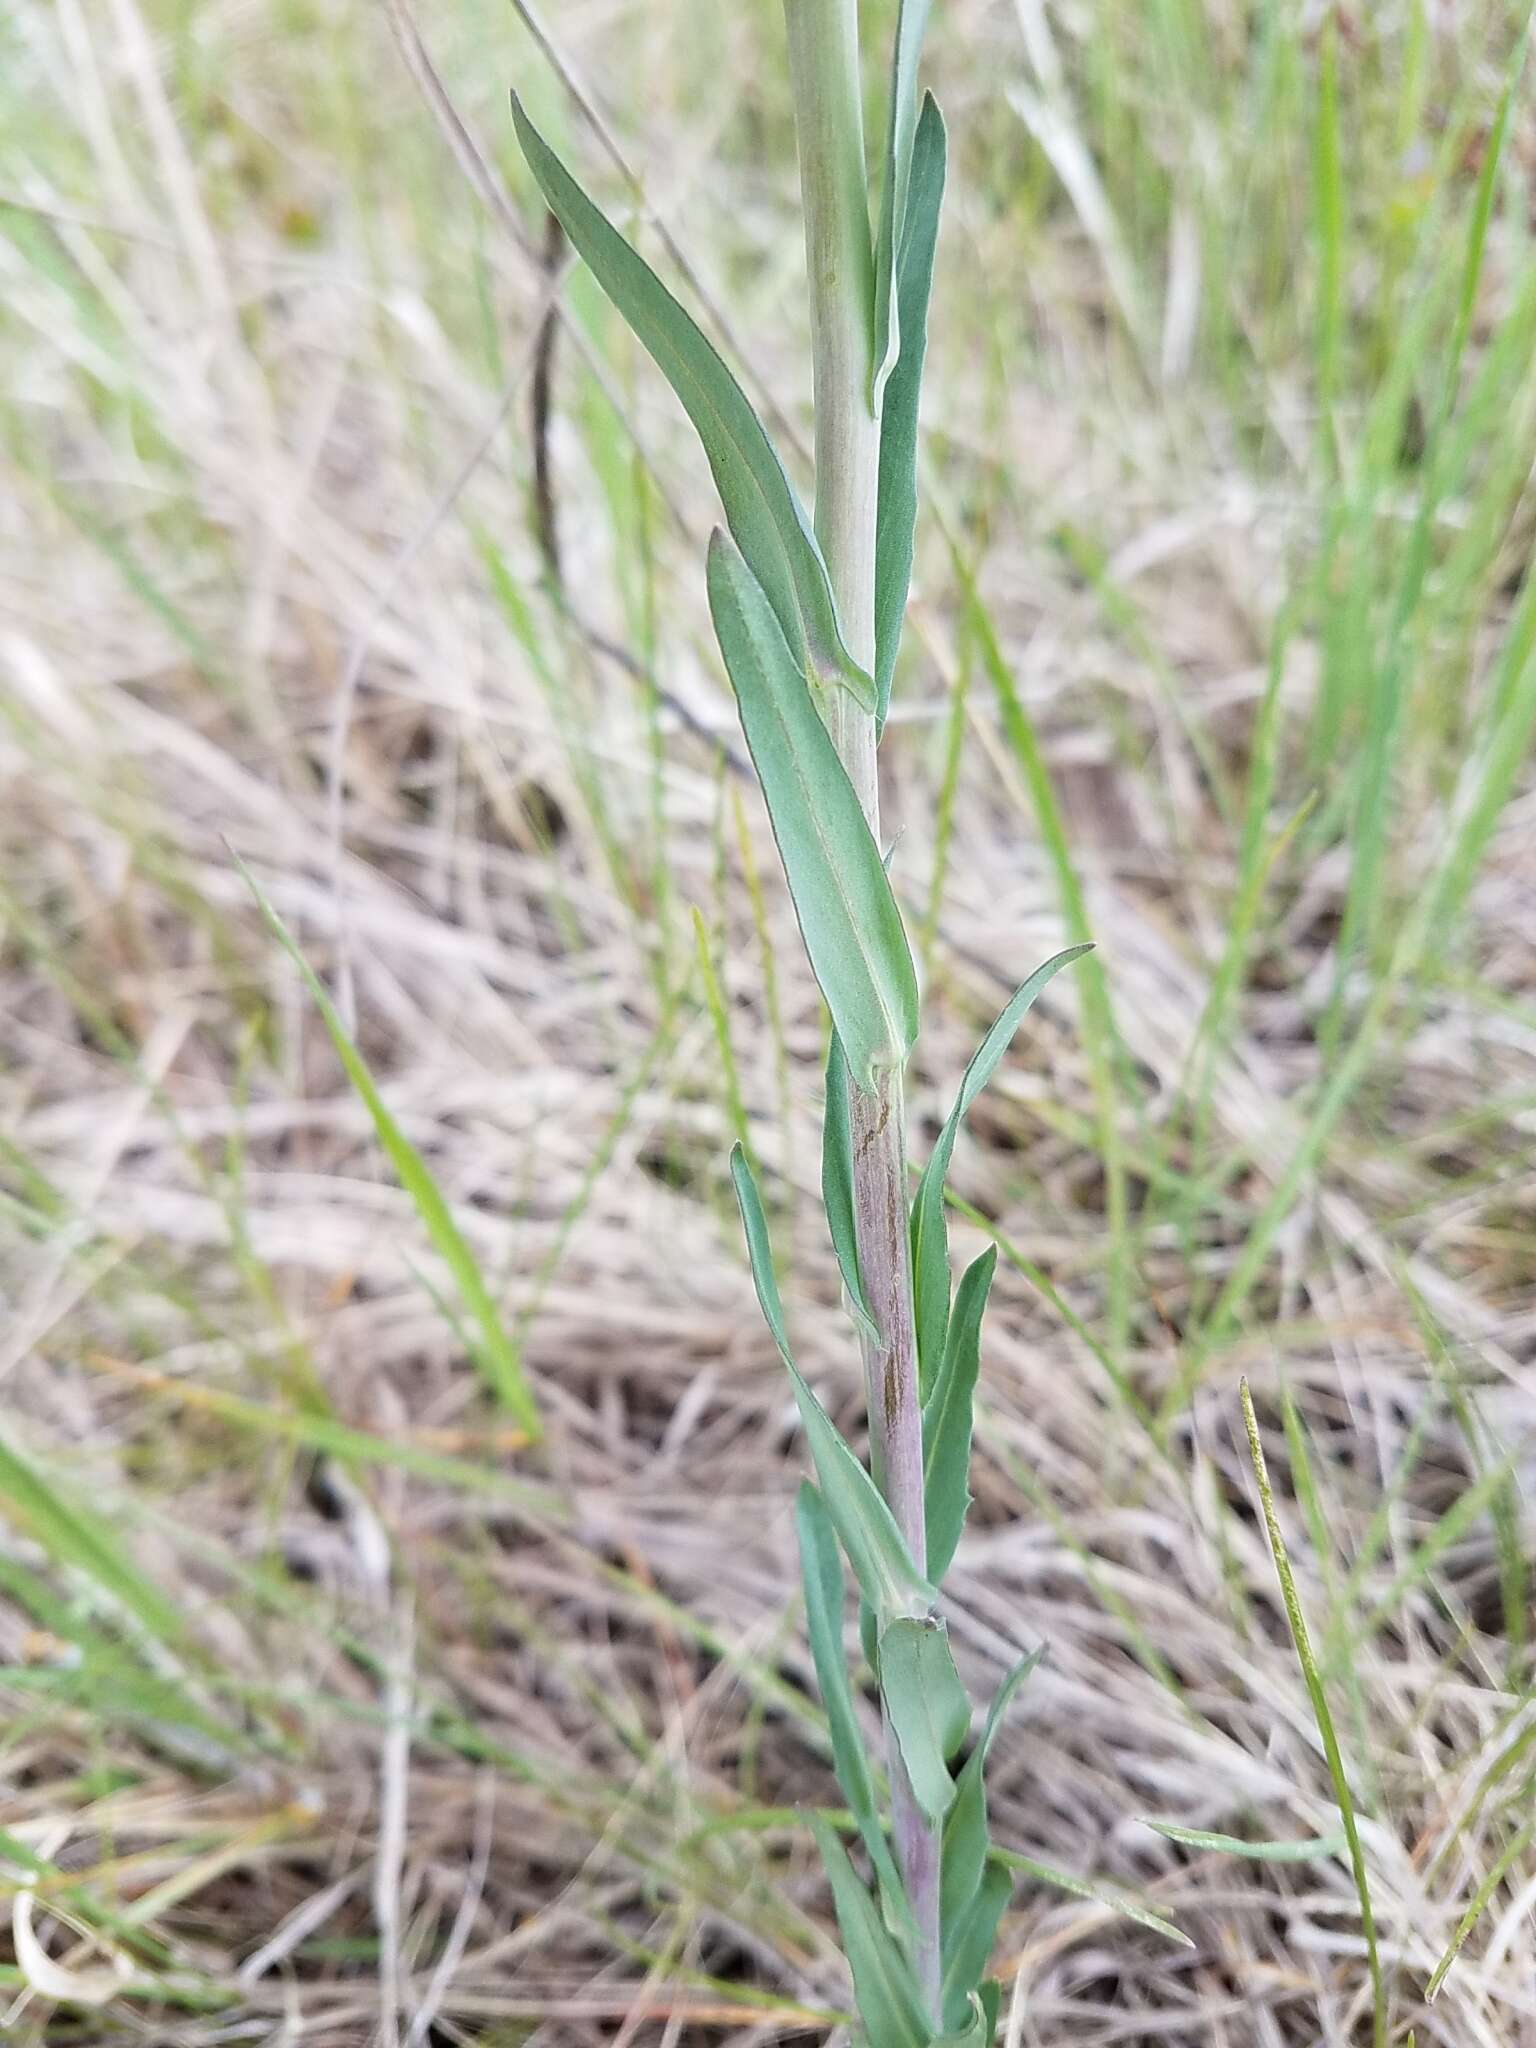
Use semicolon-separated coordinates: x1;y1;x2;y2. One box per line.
0;0;1536;2048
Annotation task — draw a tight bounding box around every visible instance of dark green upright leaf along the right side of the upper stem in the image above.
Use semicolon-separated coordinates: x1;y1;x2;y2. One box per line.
874;94;946;727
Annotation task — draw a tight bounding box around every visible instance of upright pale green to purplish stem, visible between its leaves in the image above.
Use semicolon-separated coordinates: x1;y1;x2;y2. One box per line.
784;0;940;2019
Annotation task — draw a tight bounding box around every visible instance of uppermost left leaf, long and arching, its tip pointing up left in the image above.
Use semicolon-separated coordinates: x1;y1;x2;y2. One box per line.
512;92;874;711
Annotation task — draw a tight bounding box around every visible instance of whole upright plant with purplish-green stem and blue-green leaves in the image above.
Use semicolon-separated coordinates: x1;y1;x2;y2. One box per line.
512;0;1087;2048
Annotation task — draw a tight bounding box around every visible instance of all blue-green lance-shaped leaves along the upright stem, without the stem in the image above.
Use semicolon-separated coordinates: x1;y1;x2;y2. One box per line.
512;0;1087;2048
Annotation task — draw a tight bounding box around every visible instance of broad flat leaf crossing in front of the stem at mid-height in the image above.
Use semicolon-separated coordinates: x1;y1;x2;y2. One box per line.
709;532;918;1094
